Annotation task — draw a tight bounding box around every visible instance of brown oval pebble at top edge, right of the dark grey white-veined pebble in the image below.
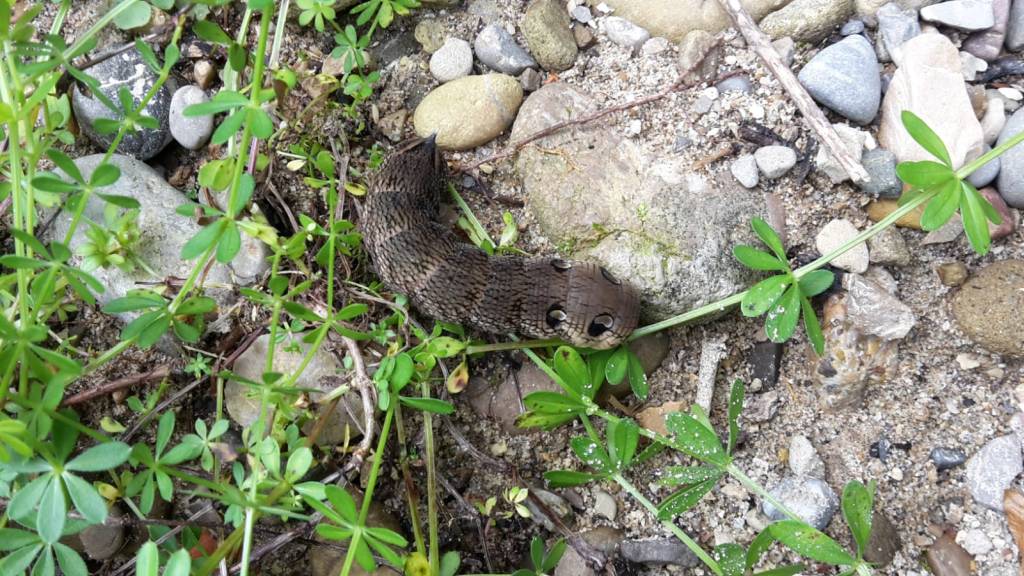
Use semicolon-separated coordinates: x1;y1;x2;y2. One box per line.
522;0;579;72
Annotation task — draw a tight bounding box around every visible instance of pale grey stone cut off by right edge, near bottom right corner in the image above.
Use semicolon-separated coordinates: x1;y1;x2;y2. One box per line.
965;434;1024;512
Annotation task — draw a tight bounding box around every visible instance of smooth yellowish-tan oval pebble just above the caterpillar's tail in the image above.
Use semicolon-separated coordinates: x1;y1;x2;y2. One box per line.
413;74;522;150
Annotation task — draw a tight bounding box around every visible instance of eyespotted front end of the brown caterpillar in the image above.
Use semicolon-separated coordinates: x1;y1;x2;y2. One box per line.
545;258;640;349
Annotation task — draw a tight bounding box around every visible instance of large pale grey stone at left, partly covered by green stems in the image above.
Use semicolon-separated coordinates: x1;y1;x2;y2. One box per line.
47;154;267;321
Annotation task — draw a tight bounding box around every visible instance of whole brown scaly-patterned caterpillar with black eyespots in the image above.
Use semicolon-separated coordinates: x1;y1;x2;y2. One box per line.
360;137;640;349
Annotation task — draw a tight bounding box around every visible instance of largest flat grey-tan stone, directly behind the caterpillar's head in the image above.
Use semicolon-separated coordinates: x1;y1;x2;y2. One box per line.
511;83;767;319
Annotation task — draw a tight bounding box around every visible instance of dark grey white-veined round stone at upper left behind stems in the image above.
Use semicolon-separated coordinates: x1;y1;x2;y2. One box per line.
72;50;174;160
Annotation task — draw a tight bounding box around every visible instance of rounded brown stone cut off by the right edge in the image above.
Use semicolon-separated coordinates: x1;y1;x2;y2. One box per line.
952;260;1024;357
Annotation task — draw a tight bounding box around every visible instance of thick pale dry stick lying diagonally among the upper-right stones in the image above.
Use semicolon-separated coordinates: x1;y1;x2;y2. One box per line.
719;0;870;183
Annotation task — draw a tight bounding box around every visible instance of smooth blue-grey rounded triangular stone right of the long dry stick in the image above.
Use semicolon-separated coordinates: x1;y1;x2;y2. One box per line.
797;35;882;124
